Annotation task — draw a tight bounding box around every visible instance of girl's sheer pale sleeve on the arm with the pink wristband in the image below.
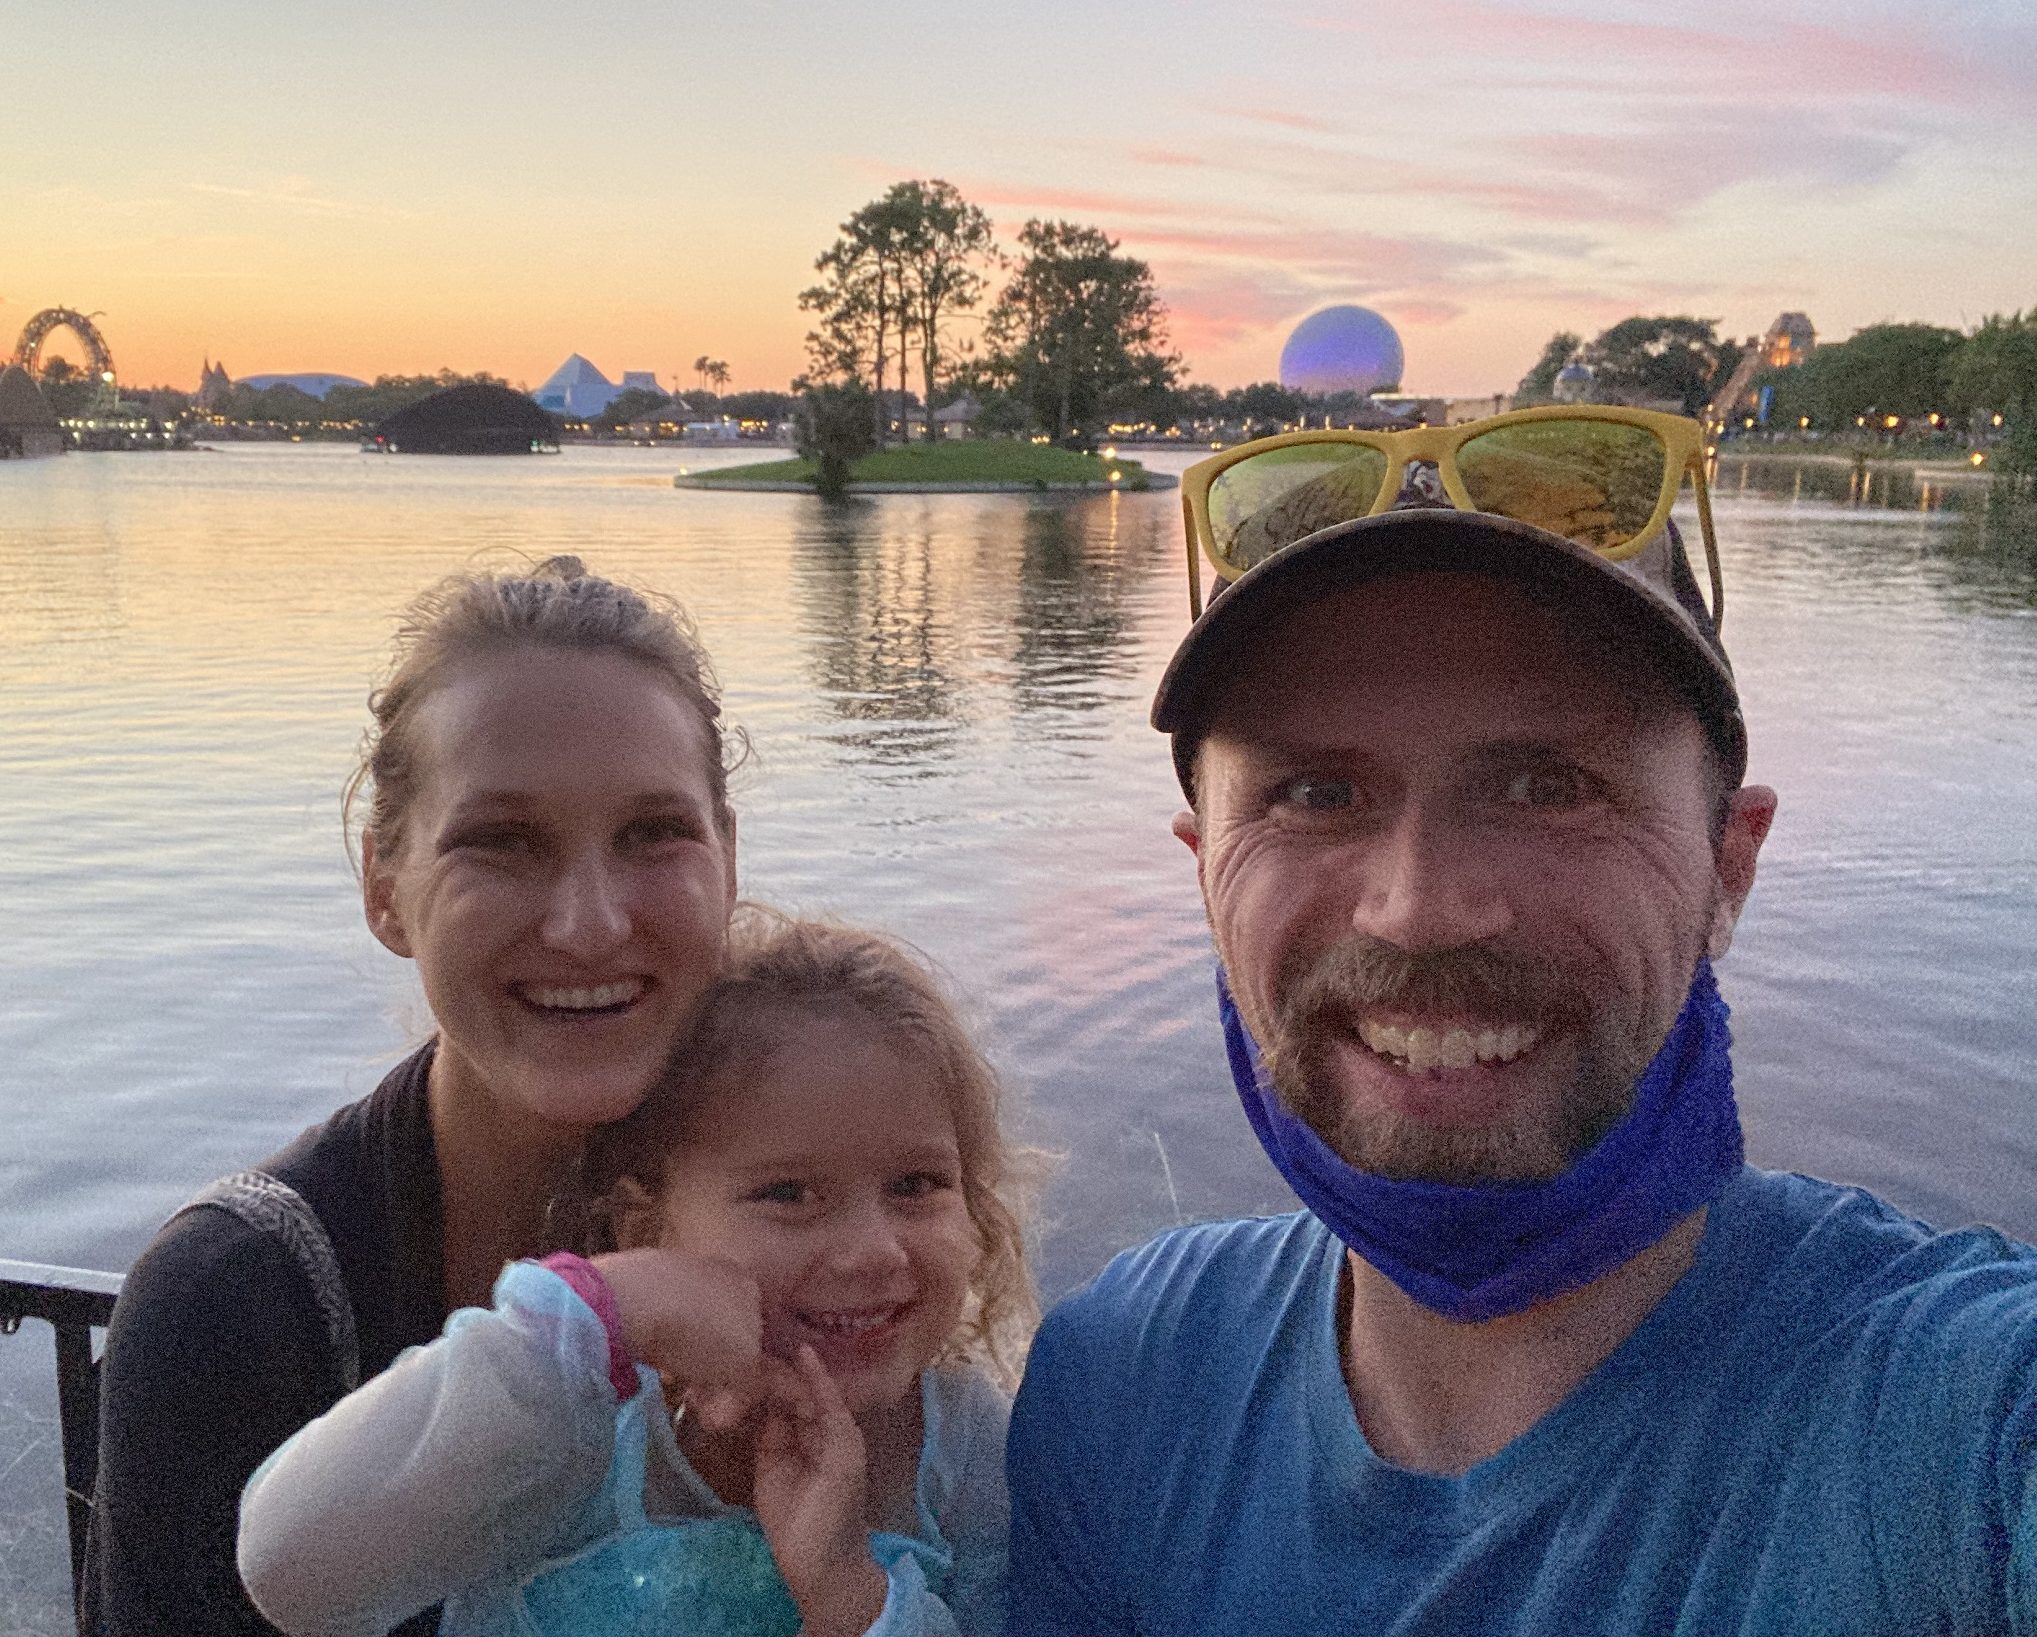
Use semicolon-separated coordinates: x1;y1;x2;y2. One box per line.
238;1262;615;1637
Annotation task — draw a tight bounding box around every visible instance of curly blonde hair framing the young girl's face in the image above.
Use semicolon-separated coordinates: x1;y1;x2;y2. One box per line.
574;904;1043;1387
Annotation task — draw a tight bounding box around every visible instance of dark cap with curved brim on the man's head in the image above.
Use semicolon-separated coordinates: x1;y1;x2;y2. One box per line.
1153;505;1748;800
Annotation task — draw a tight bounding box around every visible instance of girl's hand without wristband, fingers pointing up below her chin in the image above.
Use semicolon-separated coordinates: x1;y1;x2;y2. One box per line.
752;1346;888;1637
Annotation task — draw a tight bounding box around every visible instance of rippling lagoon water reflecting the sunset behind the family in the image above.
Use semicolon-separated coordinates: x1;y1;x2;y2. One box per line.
0;446;2037;1633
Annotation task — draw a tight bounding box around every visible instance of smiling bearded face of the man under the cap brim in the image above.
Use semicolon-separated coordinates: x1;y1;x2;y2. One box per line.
1175;574;1774;1183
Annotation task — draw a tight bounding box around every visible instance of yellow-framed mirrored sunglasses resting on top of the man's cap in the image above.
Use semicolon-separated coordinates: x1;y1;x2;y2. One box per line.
1181;403;1725;629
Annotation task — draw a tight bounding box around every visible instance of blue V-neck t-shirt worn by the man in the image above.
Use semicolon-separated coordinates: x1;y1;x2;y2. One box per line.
1008;1169;2037;1637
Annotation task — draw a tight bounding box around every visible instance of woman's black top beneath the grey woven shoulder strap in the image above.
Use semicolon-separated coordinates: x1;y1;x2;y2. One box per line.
79;1045;446;1637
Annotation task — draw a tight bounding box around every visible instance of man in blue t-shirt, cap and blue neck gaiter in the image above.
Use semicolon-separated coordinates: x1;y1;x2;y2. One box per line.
1010;425;2037;1637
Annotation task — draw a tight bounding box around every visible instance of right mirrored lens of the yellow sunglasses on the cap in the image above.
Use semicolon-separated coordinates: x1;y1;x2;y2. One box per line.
1456;419;1668;552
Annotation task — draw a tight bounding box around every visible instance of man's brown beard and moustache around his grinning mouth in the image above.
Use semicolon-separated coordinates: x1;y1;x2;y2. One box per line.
1265;935;1658;1183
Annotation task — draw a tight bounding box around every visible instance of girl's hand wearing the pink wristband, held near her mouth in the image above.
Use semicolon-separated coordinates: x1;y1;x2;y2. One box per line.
593;1246;764;1425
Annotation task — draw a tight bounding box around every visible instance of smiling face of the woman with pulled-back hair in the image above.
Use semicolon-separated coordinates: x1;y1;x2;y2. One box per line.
363;650;735;1130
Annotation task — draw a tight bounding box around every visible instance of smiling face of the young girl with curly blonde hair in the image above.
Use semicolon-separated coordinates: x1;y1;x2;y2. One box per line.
658;1010;978;1415
